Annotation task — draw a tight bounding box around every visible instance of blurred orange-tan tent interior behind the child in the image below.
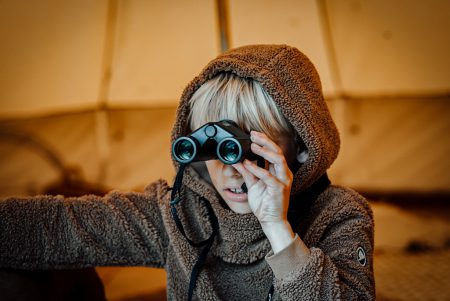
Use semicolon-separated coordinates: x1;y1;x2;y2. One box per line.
0;0;450;300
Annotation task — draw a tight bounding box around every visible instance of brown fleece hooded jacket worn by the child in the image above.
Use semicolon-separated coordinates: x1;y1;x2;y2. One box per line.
0;45;375;300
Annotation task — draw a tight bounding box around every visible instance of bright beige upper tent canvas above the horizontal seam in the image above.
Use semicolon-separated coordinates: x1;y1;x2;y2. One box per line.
0;0;450;117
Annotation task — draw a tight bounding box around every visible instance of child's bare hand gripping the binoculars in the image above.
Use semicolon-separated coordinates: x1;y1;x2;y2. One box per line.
233;131;293;251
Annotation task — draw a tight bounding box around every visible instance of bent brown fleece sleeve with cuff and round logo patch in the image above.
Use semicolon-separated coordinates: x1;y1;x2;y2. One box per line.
266;188;375;301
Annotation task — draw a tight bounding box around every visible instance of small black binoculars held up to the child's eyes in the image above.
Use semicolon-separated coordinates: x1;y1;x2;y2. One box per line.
172;120;264;165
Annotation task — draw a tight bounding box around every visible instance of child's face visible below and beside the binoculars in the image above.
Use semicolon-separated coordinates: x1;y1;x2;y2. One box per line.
205;136;296;214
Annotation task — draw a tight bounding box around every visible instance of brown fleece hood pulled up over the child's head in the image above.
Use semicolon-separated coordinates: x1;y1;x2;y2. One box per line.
172;45;340;194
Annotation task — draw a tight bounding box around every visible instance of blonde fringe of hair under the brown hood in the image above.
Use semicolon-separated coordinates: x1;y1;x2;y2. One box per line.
188;73;294;139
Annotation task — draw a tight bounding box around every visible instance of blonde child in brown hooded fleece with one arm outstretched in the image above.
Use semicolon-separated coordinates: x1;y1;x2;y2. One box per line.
0;45;375;300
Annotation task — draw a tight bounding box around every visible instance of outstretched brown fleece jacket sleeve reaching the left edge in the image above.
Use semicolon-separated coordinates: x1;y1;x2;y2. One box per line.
0;181;168;269
